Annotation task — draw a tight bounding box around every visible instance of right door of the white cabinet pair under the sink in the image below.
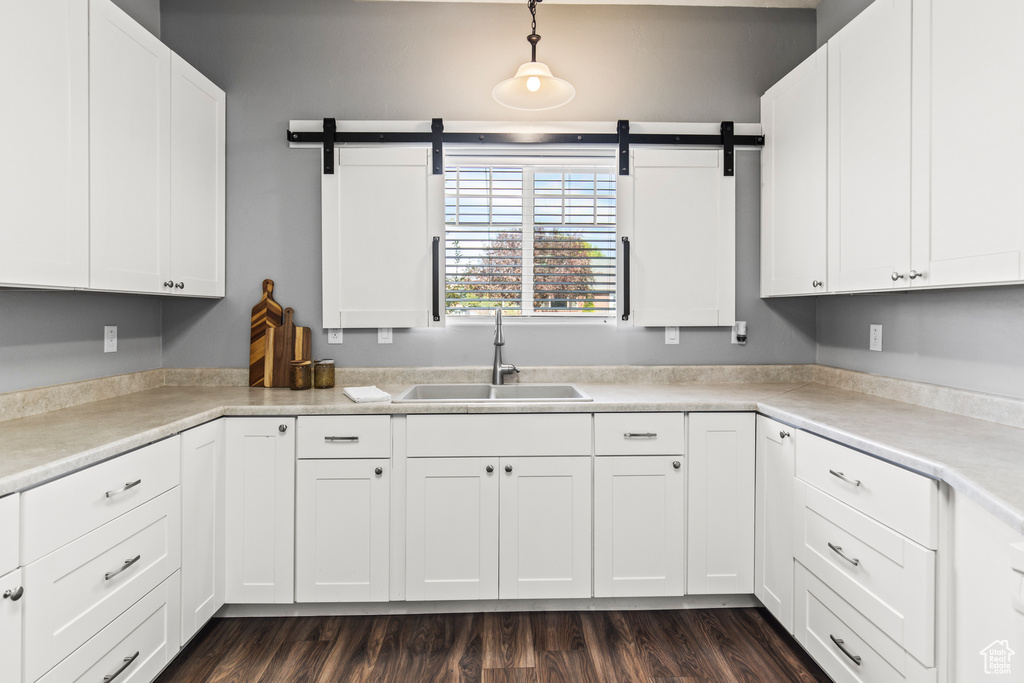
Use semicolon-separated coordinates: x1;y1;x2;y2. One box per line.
498;458;592;599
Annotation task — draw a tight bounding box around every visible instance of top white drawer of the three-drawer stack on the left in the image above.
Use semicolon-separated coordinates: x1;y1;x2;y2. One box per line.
22;436;181;565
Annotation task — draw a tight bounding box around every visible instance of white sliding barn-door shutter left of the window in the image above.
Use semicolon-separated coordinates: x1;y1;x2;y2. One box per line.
322;145;444;328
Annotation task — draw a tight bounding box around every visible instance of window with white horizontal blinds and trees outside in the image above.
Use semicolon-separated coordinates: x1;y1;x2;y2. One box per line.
444;158;615;317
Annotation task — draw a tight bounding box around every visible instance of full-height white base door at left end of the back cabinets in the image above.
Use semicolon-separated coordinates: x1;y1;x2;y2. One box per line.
224;418;295;603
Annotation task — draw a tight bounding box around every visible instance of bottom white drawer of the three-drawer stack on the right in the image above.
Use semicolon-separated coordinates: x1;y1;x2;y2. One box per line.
795;562;936;683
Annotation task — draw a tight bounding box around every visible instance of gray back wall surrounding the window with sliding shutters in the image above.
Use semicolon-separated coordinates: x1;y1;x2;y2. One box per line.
162;0;815;368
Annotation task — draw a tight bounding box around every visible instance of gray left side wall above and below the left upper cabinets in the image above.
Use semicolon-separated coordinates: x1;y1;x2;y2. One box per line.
0;0;161;393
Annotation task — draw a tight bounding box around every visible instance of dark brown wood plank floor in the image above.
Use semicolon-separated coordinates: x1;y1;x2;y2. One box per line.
158;608;829;683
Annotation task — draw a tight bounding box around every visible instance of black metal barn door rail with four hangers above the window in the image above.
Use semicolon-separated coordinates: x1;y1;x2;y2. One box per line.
288;119;765;175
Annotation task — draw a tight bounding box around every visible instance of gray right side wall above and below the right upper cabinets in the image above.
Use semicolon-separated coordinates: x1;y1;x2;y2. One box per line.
817;0;1024;398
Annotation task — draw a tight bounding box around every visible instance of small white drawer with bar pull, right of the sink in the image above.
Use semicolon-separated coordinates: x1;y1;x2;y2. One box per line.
594;413;686;456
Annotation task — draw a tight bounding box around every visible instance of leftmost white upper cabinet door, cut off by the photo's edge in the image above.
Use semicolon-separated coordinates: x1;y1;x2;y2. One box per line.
0;0;88;287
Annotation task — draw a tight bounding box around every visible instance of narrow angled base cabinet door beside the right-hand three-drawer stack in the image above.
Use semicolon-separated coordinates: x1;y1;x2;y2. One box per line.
754;415;796;633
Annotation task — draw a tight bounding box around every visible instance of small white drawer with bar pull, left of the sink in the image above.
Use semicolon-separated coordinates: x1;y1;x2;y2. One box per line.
295;415;391;460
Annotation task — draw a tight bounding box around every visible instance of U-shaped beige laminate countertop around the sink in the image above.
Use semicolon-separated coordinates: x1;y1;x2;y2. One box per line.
0;383;1024;531
